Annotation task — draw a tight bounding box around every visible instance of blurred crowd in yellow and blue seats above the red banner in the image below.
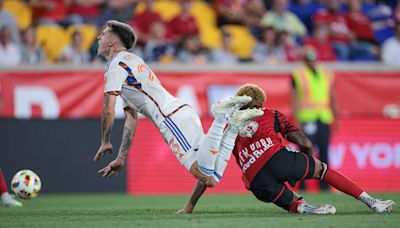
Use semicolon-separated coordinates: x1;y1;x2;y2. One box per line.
0;0;400;67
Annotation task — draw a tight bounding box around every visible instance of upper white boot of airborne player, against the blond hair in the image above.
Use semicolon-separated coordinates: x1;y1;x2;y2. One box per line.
211;96;252;118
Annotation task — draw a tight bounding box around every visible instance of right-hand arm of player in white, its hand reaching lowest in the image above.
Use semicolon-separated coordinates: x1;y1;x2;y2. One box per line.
99;108;138;177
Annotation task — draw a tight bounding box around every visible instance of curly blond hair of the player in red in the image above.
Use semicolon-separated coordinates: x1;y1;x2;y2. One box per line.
236;83;267;109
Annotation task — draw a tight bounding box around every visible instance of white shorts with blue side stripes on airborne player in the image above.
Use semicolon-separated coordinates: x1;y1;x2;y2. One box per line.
159;106;204;171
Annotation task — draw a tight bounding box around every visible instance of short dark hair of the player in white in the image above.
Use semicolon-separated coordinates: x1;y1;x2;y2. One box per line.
107;20;137;49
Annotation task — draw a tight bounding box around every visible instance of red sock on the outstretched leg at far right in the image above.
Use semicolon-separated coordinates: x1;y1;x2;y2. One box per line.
324;168;363;199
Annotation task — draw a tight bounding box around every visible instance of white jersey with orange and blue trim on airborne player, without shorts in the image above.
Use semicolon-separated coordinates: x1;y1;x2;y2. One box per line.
104;51;184;127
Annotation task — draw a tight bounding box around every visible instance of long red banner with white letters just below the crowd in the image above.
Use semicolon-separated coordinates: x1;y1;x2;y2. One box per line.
0;70;400;119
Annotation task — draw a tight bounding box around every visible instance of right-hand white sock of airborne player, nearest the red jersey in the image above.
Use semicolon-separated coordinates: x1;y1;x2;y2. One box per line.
213;126;239;182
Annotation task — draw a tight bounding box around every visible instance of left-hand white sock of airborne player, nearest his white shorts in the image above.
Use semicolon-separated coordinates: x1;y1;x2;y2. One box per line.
197;115;227;176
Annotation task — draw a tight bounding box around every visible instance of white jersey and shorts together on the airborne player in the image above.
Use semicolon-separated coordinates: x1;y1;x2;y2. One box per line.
104;52;204;170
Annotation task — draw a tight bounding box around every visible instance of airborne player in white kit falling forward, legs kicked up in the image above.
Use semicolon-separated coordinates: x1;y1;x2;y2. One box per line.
94;21;263;187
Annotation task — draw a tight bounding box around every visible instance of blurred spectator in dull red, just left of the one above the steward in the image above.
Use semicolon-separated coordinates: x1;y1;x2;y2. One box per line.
277;31;303;62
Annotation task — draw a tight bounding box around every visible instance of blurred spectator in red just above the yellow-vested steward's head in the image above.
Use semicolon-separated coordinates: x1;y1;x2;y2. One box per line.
303;24;336;62
